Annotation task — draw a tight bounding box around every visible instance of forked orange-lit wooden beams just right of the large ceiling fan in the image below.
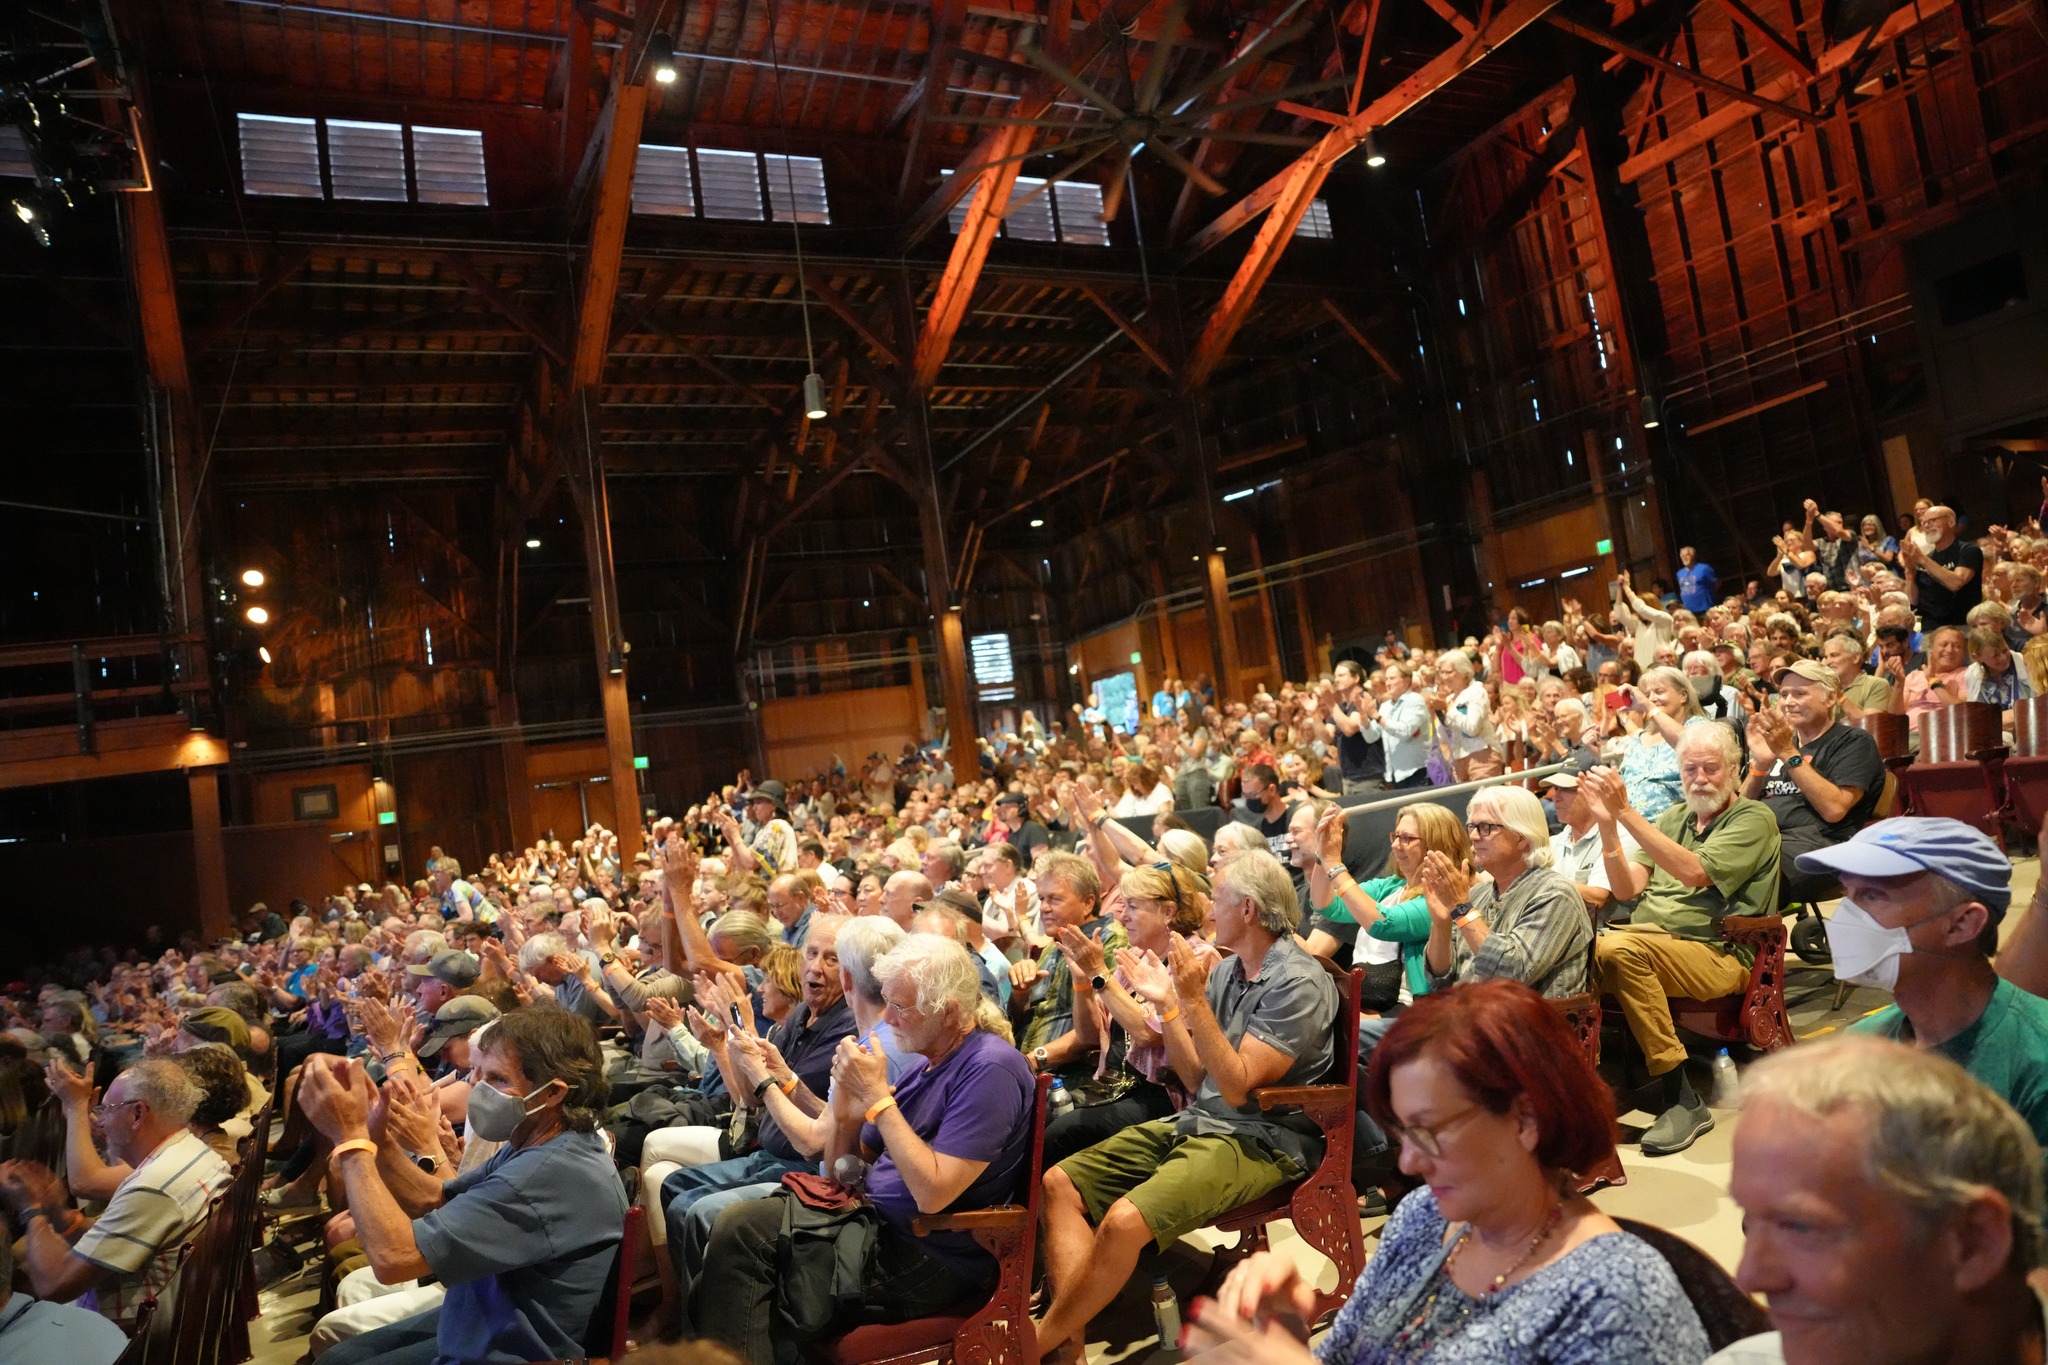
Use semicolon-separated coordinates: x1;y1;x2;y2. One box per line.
1180;0;1559;389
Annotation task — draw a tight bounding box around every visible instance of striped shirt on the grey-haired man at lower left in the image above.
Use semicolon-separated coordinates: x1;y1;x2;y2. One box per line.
72;1130;229;1326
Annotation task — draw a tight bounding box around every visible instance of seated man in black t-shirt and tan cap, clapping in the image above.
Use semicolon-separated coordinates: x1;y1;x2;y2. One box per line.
1743;659;1884;905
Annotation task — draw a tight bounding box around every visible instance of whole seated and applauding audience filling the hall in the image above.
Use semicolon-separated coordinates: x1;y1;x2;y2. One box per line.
12;503;2048;1365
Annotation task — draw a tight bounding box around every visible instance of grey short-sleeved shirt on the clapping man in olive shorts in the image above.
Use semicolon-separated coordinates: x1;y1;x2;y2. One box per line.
1174;937;1337;1175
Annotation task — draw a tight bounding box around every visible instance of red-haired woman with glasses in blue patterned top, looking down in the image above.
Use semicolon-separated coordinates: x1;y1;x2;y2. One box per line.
1190;980;1708;1365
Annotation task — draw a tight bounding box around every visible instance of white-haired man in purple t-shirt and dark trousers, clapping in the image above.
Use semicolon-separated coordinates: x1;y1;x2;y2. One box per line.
682;933;1036;1365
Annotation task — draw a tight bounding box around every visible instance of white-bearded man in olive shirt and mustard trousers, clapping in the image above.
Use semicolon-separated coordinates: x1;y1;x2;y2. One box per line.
1579;722;1778;1156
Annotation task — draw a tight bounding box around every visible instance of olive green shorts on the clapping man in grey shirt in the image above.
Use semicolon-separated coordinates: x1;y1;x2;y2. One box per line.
1059;1119;1305;1250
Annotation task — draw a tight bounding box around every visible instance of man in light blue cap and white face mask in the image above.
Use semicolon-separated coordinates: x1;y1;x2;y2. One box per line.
1798;817;2048;1170
